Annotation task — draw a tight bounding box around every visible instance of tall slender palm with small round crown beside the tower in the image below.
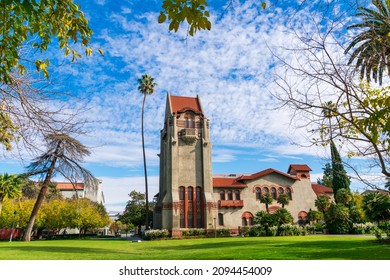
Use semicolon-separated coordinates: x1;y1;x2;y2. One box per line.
138;74;156;229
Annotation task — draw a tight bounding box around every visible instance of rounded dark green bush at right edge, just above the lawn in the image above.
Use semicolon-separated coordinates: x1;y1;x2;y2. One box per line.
363;192;390;223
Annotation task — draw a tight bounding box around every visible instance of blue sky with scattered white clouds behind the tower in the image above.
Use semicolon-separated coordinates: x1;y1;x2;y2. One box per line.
2;0;384;211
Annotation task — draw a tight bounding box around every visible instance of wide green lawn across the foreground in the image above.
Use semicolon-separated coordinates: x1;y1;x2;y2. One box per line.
0;236;390;260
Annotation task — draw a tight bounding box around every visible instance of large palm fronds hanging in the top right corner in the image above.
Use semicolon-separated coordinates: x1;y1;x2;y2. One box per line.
345;0;390;84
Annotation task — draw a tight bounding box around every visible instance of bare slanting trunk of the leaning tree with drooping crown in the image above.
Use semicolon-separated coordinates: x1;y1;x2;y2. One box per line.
23;153;57;241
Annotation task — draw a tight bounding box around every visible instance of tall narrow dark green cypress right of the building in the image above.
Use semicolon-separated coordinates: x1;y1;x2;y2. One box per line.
330;140;351;198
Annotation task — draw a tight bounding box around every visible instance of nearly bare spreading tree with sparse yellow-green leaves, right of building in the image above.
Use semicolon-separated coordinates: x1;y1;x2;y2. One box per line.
275;21;390;189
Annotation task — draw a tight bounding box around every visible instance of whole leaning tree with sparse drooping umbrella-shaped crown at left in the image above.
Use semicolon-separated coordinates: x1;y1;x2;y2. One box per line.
23;134;97;241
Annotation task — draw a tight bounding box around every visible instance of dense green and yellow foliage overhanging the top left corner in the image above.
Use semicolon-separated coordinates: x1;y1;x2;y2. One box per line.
0;0;102;84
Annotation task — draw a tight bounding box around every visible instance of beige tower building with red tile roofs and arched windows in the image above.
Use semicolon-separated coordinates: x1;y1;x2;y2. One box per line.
153;94;333;236
